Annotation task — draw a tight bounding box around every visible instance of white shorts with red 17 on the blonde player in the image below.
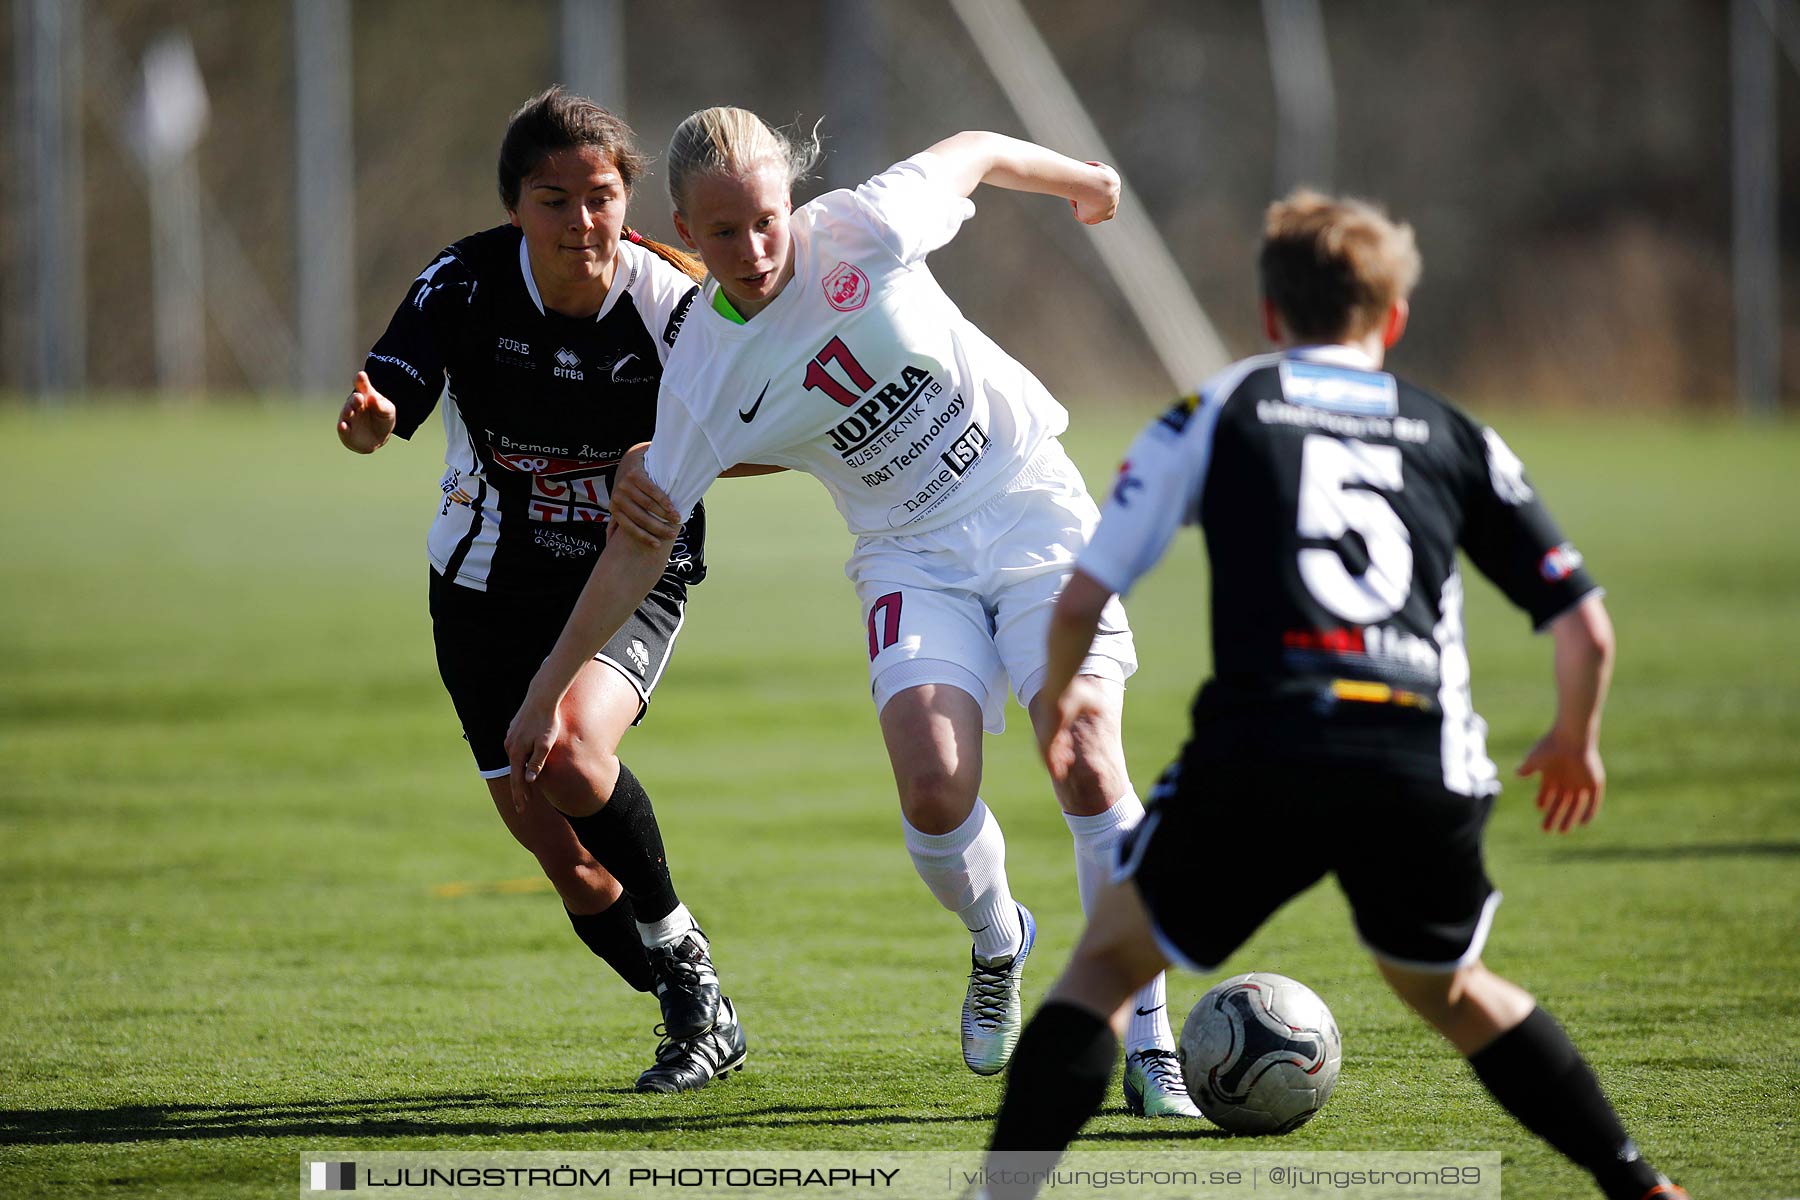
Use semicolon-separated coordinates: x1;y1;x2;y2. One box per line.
844;439;1138;734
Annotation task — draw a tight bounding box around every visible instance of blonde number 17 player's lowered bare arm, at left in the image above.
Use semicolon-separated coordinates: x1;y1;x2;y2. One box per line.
506;538;675;811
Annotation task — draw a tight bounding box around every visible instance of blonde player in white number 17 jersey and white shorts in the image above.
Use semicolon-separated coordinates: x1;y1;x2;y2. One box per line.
508;108;1197;1115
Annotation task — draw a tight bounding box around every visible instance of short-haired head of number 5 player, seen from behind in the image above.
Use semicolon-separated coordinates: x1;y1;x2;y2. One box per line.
1256;187;1422;345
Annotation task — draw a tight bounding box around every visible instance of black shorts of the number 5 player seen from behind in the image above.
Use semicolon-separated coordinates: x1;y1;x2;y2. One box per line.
1114;759;1499;972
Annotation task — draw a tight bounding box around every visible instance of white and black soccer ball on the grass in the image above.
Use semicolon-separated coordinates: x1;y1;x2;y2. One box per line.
1179;972;1343;1133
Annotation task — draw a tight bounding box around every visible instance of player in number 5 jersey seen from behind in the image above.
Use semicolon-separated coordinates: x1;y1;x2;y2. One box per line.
990;193;1687;1200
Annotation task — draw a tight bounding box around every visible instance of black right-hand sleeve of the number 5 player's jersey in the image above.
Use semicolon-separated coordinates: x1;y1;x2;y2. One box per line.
1458;414;1598;630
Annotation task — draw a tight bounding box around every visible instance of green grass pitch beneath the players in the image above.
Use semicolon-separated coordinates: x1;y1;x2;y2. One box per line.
0;401;1800;1200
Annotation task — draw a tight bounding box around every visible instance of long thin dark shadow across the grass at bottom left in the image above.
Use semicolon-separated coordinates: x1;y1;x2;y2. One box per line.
0;1090;964;1146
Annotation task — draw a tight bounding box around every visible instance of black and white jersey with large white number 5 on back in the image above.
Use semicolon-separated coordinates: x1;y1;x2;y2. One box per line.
1080;345;1595;795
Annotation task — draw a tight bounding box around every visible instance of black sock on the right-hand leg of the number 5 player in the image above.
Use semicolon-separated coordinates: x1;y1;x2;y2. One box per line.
1469;1007;1658;1200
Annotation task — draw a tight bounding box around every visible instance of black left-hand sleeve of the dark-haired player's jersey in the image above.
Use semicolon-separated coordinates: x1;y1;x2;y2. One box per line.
364;246;475;437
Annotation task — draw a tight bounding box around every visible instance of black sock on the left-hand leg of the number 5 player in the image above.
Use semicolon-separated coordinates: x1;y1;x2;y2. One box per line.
988;1000;1120;1158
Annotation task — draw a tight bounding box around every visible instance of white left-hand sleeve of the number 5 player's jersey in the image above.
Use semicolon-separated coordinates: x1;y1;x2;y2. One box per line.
1076;399;1219;596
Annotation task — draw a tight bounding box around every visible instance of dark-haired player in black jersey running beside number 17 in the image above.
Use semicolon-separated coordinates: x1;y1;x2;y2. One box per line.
338;88;745;1092
